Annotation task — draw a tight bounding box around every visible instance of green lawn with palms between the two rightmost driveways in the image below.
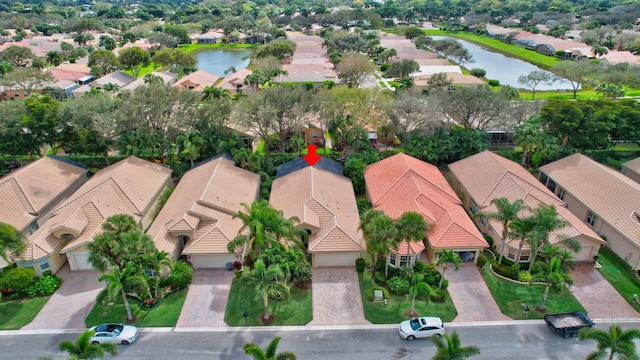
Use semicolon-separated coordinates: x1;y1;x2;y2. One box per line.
480;257;586;320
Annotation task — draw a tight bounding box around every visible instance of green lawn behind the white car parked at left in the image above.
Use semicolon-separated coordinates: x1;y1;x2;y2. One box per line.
84;289;187;327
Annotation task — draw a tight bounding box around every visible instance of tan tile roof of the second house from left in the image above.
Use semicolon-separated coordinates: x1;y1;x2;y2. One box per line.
24;156;171;260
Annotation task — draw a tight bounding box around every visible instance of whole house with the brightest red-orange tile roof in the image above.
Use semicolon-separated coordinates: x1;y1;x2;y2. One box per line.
364;154;489;267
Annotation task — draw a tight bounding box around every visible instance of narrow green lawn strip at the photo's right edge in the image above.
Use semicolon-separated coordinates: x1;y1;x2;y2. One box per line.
598;247;640;312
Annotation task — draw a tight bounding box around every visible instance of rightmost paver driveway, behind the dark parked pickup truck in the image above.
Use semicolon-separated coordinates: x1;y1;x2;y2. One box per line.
570;264;640;320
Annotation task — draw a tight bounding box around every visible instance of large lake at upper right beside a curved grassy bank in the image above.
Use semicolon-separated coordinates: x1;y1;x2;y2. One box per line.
432;36;572;91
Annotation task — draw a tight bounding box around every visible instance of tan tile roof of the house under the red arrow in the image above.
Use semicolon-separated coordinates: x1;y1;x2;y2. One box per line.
269;166;366;253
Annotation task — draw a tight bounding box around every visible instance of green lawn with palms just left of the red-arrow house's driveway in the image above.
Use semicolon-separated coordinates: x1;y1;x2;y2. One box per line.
224;278;313;326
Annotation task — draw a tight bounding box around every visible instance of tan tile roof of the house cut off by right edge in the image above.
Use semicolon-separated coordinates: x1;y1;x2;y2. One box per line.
540;154;640;246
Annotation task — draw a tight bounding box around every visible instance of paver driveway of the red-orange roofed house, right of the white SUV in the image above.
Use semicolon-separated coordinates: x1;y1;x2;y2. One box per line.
445;265;511;322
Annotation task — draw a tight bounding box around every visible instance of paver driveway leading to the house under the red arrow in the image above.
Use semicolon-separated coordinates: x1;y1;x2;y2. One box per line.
309;267;370;325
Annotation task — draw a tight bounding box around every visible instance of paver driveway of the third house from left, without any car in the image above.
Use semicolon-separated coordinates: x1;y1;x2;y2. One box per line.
176;269;233;327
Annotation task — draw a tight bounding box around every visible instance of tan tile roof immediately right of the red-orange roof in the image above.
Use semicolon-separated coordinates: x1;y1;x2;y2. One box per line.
449;151;603;243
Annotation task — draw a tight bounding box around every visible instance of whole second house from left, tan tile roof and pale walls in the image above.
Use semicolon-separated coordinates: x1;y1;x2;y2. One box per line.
16;156;173;274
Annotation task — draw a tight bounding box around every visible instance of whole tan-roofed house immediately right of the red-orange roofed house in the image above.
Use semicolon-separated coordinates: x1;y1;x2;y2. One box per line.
449;151;604;263
